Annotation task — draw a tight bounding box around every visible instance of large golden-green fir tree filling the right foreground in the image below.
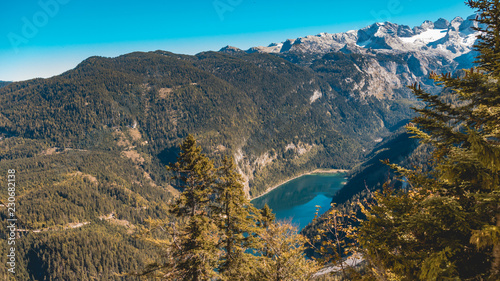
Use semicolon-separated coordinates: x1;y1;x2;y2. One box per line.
359;0;500;280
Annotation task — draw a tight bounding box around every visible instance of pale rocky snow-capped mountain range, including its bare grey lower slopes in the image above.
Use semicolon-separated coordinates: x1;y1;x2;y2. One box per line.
221;15;478;99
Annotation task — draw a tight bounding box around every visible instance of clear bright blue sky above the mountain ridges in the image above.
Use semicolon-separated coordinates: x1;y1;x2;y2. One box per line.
0;0;473;81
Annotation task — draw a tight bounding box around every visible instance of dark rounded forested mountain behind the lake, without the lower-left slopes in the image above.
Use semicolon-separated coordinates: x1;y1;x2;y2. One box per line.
0;49;411;199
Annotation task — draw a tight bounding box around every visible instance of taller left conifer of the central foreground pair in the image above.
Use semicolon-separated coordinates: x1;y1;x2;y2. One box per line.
168;135;220;281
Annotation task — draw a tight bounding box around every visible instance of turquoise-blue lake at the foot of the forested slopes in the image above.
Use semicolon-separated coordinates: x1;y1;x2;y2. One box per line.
252;173;346;230
